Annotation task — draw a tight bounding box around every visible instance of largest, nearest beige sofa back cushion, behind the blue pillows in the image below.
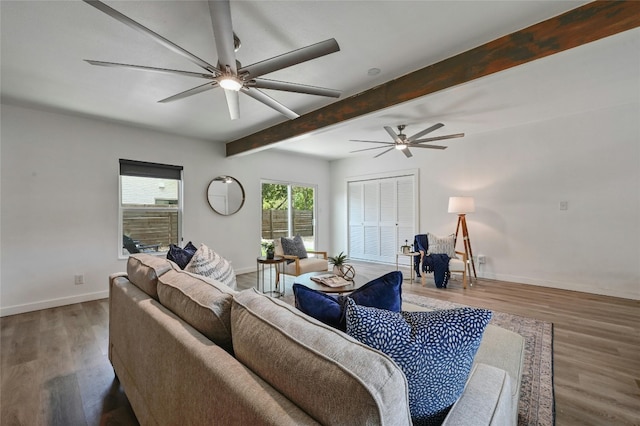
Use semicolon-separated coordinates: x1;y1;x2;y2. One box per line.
231;289;411;425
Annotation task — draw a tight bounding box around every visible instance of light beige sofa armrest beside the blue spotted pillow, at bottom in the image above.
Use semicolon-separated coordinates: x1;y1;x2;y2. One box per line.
442;364;516;426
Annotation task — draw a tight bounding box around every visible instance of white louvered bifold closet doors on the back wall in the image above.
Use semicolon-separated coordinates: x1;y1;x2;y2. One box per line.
348;175;417;263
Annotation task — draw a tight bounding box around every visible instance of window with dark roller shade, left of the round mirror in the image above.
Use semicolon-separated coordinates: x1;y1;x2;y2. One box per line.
119;159;182;256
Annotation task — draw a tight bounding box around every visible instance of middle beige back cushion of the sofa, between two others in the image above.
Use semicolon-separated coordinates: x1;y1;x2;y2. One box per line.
158;270;236;353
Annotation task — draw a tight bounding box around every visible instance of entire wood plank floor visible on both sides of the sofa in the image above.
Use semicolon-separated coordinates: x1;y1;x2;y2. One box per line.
0;262;640;426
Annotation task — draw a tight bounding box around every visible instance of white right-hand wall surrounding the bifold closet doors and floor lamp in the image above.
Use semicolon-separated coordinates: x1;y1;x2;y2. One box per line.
331;102;640;299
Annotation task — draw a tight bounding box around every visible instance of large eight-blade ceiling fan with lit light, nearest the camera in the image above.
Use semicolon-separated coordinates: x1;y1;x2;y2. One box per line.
84;0;340;120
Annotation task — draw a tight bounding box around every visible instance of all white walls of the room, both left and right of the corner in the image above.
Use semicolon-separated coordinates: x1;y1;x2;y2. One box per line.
0;95;640;315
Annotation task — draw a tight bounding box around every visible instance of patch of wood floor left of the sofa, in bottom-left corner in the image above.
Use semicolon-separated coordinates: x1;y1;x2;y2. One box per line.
0;299;138;426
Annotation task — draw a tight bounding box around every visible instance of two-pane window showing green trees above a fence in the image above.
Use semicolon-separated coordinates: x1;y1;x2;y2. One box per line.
262;182;316;250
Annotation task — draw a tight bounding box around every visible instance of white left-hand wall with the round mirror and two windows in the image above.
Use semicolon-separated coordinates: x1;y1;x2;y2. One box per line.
0;105;330;315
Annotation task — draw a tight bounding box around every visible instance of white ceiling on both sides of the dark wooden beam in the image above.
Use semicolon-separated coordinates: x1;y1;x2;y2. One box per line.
0;0;640;159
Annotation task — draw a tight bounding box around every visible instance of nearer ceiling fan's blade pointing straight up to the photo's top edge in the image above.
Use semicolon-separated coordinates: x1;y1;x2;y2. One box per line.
209;0;238;75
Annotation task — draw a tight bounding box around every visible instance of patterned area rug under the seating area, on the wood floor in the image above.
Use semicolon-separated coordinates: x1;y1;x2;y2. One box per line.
402;294;555;426
